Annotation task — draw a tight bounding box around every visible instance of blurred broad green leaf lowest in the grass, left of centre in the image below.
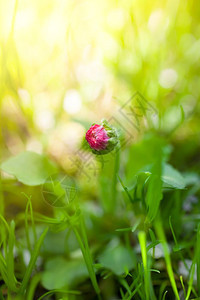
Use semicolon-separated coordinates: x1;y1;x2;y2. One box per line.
42;257;89;290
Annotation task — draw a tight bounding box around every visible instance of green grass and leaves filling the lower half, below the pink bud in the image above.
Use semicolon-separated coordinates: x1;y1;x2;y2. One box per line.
0;129;199;300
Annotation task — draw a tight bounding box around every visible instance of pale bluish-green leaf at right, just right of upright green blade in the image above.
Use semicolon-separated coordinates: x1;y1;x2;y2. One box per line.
162;164;185;189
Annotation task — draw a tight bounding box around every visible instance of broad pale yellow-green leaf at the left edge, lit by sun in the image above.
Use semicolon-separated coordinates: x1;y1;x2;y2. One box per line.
1;151;56;186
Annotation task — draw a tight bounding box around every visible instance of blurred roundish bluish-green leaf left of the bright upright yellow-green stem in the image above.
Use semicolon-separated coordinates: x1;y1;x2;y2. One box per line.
99;245;136;275
